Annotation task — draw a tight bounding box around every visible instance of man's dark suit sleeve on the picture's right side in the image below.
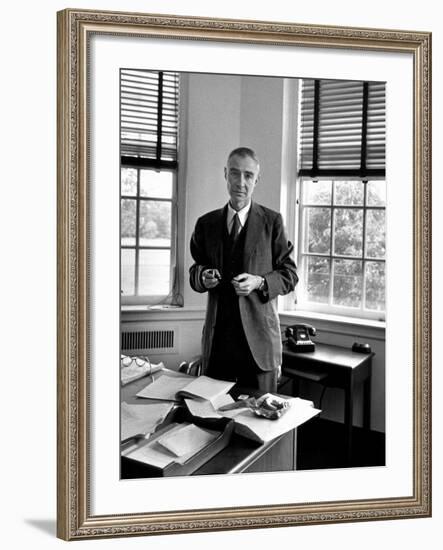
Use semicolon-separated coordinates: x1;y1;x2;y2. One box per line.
260;214;298;302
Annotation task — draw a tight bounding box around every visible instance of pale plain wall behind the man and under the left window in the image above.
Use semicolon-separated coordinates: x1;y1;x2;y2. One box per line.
122;73;283;368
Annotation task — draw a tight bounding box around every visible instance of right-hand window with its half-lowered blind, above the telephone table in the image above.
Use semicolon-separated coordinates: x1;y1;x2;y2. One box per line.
297;80;386;319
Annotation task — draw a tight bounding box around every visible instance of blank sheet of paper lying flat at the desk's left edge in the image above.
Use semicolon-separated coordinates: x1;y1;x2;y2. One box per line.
120;402;174;441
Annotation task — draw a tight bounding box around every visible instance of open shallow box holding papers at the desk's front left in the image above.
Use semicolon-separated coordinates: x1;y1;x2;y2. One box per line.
121;407;234;479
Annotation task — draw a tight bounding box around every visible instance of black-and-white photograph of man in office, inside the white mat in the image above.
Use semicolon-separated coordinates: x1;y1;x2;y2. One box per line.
119;67;390;479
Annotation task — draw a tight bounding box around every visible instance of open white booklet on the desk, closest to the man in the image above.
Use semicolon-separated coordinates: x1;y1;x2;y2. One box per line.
137;372;235;404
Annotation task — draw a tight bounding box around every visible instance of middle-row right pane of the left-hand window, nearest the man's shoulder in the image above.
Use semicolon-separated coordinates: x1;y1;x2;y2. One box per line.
139;201;171;246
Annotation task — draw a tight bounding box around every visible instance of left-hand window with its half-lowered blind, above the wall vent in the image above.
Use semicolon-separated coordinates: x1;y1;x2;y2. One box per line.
120;70;180;304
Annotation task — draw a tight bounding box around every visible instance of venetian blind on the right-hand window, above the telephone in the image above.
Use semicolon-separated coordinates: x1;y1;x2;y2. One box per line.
299;79;386;179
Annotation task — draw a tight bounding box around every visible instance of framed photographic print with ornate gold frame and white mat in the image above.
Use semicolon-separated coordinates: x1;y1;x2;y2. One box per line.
58;9;431;540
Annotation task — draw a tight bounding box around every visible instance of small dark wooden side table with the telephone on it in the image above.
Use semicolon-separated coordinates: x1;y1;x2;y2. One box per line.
282;344;374;464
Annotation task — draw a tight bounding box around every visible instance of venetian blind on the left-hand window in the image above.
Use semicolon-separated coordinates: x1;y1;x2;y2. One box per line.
120;69;178;167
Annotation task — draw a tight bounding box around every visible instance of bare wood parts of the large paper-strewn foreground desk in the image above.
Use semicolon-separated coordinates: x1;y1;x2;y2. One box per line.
120;375;297;479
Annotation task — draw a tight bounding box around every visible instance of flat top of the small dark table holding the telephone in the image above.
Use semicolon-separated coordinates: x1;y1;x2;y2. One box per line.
283;343;374;369
